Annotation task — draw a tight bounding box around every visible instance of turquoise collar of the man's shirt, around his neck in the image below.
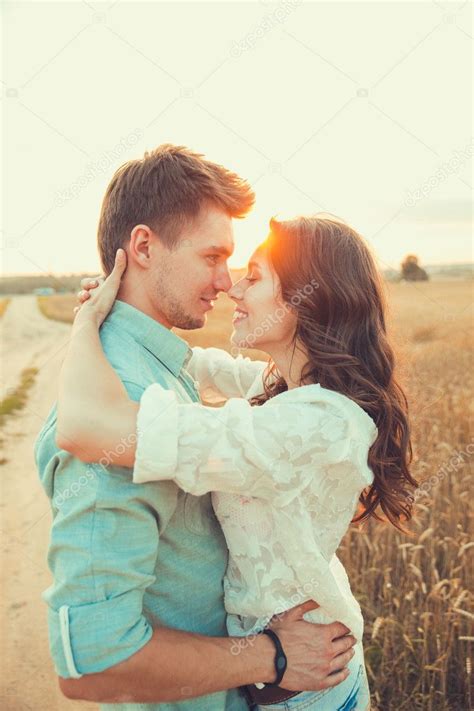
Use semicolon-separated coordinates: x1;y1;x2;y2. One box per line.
104;300;192;377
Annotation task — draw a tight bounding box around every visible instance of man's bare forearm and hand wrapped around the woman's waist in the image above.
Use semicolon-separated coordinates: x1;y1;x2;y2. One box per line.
59;603;355;703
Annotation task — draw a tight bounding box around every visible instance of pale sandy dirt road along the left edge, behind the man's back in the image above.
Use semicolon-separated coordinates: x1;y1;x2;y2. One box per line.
0;296;98;711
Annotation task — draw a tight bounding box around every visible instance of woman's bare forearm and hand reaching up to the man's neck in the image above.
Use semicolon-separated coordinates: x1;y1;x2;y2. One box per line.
56;250;138;467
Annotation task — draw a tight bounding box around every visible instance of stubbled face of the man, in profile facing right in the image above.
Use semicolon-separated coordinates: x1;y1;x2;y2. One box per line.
149;207;234;329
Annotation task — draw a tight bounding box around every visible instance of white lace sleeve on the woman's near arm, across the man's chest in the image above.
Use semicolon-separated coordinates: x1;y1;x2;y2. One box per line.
133;384;364;503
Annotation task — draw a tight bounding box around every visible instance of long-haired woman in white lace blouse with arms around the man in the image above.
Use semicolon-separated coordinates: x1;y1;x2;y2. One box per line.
58;216;416;711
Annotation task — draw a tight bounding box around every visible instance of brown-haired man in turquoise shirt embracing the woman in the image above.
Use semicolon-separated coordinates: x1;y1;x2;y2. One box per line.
35;145;353;711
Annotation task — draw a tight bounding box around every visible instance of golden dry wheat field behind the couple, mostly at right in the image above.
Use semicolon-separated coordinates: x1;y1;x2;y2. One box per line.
39;281;474;711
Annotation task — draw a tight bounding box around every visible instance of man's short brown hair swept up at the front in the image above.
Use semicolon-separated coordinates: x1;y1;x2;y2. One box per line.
97;143;255;274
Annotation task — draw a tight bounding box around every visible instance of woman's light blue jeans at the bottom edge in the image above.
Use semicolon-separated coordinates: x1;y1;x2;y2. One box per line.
257;644;370;711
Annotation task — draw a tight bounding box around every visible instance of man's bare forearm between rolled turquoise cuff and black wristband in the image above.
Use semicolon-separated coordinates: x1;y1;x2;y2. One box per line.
60;628;275;703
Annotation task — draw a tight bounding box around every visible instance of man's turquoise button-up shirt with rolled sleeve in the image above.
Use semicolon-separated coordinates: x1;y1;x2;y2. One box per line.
35;301;247;711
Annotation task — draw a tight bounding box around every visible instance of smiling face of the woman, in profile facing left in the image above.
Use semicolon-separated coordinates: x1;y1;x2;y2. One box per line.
228;243;297;354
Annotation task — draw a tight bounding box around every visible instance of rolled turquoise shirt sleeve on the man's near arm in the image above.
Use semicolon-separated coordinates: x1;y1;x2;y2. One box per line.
36;383;159;678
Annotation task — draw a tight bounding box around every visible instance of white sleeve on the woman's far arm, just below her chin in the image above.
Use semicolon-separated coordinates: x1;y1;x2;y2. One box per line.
187;346;267;402
